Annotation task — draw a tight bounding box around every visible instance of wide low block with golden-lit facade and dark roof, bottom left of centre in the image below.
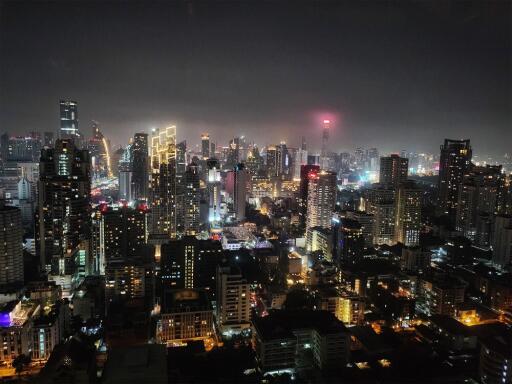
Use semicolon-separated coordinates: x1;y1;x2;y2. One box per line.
156;289;215;346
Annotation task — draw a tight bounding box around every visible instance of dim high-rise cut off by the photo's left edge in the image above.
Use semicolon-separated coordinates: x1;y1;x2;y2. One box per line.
0;206;23;290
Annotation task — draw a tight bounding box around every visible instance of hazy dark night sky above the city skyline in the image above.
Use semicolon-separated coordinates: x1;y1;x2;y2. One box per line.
0;0;512;156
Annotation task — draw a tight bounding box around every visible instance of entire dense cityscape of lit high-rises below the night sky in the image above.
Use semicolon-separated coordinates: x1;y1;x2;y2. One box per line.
0;101;512;384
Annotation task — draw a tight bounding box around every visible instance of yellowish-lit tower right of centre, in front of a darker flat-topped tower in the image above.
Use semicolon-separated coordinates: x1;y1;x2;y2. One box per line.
395;180;423;247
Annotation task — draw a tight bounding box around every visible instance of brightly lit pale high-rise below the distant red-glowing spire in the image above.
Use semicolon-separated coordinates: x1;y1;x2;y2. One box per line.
306;171;336;237
